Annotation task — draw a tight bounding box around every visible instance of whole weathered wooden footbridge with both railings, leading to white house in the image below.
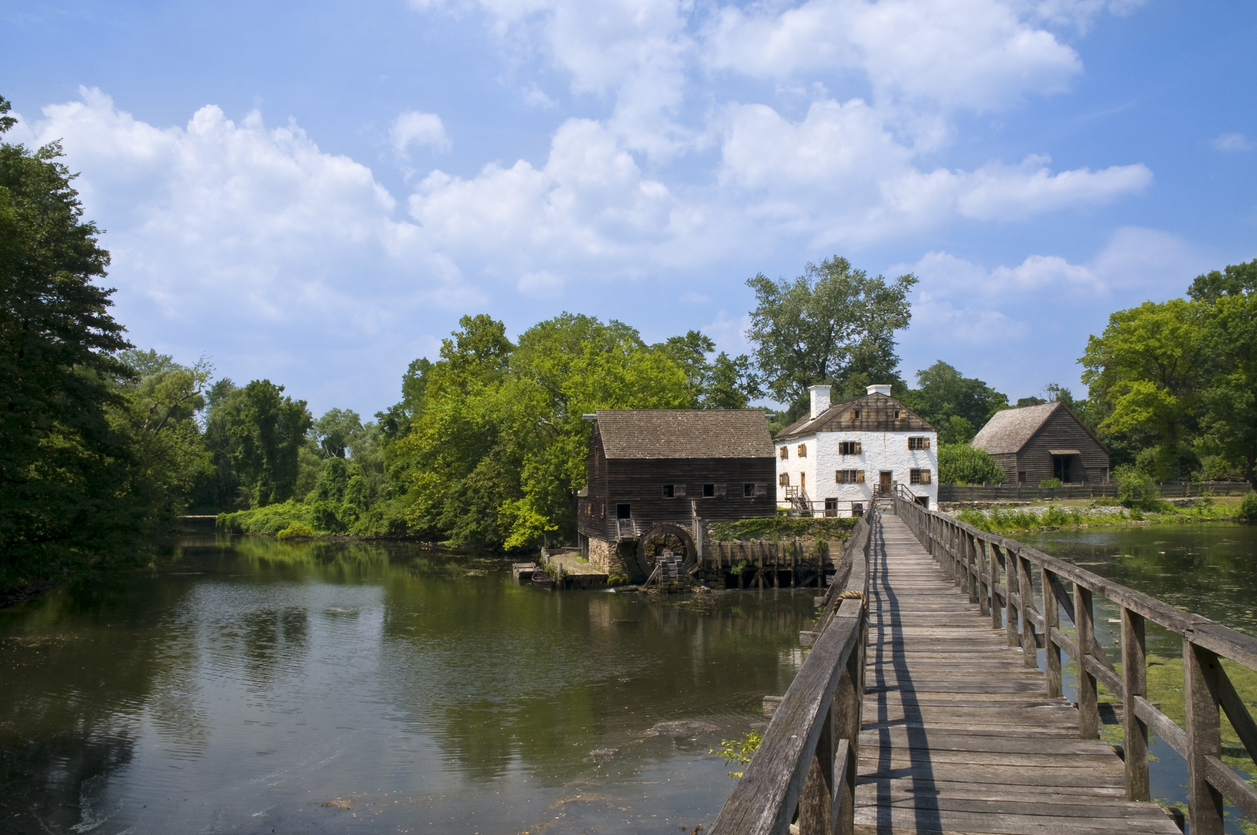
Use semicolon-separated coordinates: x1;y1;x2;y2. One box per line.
711;497;1257;835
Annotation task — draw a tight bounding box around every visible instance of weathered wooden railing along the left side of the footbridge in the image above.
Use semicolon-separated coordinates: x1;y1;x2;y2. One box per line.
710;516;871;835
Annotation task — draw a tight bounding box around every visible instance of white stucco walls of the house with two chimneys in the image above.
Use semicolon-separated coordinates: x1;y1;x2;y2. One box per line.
776;431;939;516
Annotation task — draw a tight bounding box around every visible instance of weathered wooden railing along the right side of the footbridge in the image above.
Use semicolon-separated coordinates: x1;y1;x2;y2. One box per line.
895;485;1257;835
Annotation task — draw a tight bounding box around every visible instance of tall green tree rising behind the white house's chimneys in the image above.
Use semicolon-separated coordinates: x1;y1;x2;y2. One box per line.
747;257;916;404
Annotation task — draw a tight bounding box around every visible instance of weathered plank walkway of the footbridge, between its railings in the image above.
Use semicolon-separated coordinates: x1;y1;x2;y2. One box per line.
855;514;1179;835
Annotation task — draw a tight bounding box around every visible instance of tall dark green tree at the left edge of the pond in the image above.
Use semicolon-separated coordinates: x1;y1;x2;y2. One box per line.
0;98;148;585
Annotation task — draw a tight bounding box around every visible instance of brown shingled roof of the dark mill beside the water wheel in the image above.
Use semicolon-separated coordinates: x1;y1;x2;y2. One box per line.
597;409;773;459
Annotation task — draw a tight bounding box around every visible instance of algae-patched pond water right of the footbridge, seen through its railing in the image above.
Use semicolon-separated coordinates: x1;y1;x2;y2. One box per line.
1017;522;1257;835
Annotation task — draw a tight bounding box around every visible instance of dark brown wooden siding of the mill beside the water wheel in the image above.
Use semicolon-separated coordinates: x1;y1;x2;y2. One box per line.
577;447;777;539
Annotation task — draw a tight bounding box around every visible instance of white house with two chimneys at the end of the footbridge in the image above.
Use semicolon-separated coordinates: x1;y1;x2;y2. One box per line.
773;386;939;516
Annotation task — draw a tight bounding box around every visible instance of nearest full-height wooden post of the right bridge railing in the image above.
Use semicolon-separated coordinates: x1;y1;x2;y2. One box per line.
1183;638;1223;835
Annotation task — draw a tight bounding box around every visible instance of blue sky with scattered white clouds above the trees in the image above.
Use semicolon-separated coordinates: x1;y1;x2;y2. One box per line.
0;0;1257;416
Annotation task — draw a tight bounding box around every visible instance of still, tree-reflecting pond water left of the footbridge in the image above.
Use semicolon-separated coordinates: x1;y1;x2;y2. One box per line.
0;536;813;835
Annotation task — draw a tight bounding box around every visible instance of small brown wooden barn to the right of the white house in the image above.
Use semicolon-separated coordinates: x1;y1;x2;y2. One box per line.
973;401;1109;484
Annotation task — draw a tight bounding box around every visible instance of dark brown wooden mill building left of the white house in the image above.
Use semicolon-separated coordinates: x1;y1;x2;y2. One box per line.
577;409;776;575
